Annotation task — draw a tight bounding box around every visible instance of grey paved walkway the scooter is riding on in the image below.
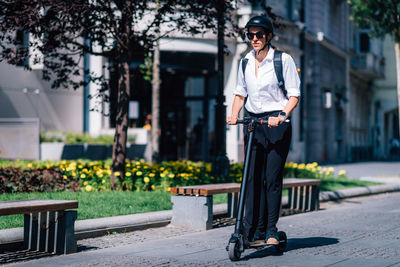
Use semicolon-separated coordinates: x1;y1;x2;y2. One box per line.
7;193;400;267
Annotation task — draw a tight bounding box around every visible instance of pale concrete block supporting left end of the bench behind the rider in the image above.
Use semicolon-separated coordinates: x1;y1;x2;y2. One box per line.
171;195;213;230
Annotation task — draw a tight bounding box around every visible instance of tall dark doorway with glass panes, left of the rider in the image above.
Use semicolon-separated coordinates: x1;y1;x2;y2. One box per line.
160;52;217;161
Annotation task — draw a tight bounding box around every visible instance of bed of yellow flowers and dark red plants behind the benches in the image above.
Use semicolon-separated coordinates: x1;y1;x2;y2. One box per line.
0;160;346;193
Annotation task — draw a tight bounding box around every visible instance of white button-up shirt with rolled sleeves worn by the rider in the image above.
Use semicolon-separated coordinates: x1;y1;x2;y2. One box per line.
233;47;300;114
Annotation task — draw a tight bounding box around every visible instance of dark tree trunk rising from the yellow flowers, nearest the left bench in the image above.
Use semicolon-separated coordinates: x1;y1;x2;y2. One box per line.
110;62;130;190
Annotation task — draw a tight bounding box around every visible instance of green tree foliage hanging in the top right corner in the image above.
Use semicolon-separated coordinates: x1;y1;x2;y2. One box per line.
350;0;400;41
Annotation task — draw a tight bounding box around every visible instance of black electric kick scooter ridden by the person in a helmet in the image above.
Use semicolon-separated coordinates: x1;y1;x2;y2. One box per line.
226;117;287;261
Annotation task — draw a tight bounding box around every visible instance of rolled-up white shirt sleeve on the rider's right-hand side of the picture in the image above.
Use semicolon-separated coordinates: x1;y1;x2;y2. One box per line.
282;53;300;97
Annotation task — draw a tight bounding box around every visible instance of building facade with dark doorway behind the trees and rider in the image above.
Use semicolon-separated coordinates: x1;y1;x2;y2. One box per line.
0;0;397;162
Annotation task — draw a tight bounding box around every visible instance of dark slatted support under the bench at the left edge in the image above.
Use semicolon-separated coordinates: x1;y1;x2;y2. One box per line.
24;211;77;254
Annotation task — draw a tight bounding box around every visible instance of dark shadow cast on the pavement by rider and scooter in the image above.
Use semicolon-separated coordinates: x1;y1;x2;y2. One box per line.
242;237;339;260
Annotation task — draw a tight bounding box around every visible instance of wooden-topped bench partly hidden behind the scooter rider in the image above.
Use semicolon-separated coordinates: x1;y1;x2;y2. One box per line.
170;178;321;230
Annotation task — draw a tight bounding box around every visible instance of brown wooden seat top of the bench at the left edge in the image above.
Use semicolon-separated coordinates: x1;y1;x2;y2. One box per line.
0;199;78;216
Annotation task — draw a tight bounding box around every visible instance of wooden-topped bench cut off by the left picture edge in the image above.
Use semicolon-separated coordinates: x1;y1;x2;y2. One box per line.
0;199;78;254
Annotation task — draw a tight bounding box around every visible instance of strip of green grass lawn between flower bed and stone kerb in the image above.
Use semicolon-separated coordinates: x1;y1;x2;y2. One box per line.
0;179;378;229
